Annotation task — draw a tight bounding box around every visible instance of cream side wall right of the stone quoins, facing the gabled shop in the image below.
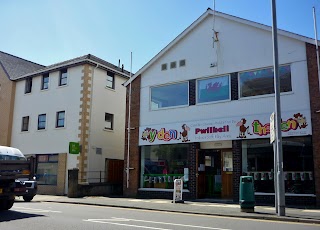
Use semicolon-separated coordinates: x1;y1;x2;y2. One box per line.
88;68;127;171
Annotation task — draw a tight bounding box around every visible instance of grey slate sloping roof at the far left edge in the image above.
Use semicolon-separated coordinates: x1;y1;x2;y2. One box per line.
0;51;44;80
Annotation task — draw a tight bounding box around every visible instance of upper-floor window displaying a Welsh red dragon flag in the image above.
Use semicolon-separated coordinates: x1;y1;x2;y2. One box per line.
197;76;230;103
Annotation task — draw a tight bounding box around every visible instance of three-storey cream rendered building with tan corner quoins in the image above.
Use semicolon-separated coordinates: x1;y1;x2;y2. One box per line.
11;54;129;195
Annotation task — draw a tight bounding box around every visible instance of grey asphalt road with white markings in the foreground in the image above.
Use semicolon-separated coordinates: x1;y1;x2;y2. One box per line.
0;202;320;230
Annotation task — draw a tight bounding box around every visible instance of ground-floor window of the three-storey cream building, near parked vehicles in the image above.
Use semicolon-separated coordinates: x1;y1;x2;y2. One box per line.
36;154;59;185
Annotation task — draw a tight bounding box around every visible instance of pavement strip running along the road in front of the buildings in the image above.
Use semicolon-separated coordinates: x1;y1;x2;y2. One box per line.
16;195;320;225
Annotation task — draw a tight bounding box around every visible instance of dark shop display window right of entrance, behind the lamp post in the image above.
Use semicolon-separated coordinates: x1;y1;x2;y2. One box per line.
242;136;315;194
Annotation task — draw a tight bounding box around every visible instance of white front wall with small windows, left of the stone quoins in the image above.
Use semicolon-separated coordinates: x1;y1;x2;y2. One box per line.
12;66;83;169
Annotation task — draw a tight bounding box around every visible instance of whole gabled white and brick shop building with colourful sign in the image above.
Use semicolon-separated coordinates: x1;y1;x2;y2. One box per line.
124;9;316;206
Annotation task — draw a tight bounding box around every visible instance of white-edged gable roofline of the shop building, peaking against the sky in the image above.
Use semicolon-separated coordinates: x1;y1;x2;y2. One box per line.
124;8;315;86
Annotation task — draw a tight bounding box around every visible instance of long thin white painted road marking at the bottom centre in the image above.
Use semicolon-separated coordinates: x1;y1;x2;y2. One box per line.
83;217;231;230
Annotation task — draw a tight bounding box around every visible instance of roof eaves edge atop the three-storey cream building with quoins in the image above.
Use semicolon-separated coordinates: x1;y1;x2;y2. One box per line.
14;54;130;80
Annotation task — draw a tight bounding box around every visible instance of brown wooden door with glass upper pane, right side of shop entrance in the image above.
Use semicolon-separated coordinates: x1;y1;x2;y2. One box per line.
221;150;233;199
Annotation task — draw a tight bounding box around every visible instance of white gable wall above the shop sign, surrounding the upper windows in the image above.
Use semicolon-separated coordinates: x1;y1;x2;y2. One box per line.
140;16;310;126
